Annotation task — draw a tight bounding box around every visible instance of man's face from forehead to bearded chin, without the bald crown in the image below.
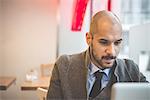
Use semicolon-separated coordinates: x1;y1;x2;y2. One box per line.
86;19;122;68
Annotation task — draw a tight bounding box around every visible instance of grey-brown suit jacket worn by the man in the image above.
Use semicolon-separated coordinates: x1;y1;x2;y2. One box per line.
47;50;146;100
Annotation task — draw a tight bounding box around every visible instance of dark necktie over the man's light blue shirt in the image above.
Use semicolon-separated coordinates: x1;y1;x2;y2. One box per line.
89;71;103;98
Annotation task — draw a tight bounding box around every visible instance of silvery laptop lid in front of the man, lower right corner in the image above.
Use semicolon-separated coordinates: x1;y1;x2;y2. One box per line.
111;83;150;100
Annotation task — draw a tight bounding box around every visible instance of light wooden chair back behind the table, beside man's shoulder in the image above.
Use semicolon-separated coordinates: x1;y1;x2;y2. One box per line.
40;63;54;77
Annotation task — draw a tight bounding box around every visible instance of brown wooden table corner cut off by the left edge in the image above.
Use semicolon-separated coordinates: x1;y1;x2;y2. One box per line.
0;76;16;90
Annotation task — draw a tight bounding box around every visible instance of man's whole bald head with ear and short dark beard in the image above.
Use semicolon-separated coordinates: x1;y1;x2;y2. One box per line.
86;10;122;68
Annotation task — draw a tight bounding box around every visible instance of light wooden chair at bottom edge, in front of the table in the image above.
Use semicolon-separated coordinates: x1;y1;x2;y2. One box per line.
37;87;48;100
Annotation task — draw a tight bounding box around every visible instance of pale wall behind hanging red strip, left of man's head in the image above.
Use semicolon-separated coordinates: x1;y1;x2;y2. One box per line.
59;0;90;55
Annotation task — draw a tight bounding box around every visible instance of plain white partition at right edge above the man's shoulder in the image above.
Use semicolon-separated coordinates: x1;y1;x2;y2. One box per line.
129;24;150;64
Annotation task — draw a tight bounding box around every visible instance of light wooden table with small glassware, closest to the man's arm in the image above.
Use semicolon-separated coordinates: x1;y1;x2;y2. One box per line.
21;77;50;90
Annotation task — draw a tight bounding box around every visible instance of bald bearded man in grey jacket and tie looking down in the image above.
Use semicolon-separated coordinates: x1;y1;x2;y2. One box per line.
47;10;147;100
